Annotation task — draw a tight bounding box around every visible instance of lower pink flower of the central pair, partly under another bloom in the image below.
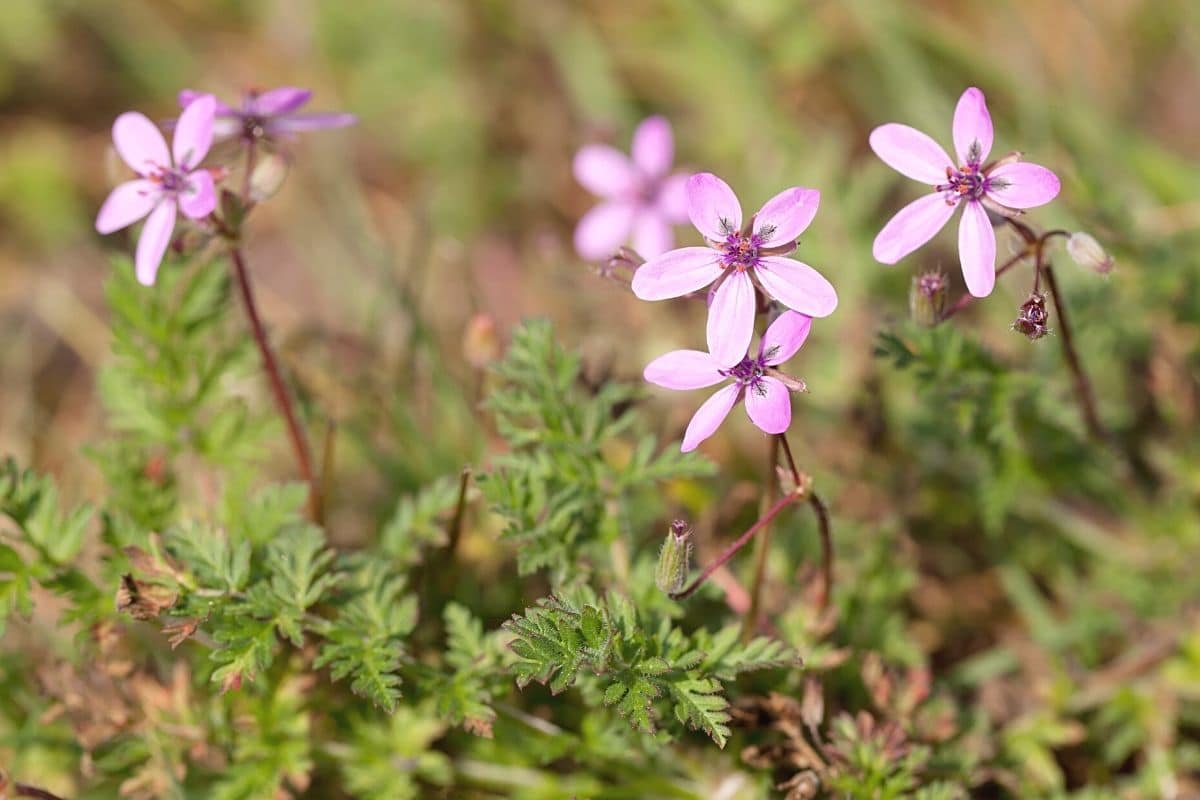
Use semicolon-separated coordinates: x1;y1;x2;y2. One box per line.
643;311;812;452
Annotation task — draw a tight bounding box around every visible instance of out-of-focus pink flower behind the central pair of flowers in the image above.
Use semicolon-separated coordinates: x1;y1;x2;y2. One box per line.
574;116;688;260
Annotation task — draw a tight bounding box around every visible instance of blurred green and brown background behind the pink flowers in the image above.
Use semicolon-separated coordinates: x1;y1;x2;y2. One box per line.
0;0;1200;501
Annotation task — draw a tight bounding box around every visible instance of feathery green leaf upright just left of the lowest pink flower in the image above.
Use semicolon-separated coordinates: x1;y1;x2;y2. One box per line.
480;321;712;584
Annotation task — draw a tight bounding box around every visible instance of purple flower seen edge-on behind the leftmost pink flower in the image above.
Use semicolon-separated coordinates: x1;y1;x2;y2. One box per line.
179;86;358;142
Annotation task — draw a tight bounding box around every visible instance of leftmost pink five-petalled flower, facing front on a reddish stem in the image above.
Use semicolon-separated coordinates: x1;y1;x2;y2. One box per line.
96;95;217;285
